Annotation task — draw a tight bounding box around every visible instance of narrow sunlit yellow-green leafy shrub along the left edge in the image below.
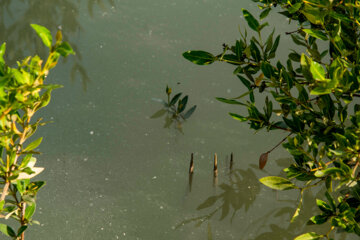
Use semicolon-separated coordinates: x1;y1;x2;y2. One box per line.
0;24;74;240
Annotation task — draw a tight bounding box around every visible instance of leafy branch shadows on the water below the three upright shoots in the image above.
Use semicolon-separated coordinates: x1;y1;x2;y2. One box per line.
175;159;354;240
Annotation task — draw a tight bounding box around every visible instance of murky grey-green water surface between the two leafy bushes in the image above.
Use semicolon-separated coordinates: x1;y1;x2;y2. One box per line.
0;0;356;240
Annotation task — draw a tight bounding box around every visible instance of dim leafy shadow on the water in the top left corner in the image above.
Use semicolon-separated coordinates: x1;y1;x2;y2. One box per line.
0;0;114;91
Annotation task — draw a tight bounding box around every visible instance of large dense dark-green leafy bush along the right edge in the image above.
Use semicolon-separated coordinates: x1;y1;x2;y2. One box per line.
183;0;360;240
